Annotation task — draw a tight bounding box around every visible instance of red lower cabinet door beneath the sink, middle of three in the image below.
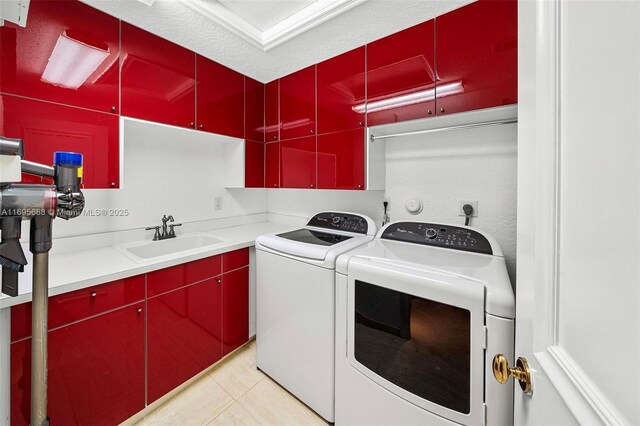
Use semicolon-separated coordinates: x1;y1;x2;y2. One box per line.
147;278;222;404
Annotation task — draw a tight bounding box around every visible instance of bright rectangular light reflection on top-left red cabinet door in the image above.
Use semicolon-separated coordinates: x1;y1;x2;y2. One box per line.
40;31;109;90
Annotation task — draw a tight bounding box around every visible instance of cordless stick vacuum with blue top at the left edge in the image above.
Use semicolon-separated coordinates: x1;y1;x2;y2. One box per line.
0;137;84;426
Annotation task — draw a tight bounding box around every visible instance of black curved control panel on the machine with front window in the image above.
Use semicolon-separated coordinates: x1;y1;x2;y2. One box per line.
381;222;493;254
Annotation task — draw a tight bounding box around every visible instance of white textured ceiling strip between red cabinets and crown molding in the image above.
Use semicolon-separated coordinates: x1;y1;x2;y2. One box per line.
82;0;473;82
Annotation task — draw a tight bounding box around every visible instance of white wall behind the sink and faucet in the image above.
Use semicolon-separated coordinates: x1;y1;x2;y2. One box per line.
49;119;267;238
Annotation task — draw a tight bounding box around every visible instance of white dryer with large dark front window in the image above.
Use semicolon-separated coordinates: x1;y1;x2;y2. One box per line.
335;222;515;425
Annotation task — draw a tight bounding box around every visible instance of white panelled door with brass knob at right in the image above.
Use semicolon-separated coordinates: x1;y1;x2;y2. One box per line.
507;0;640;425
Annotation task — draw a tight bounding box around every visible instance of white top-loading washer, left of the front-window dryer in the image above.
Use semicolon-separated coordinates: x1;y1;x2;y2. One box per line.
256;212;376;422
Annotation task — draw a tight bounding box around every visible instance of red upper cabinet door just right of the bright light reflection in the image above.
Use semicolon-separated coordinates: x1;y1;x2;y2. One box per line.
120;22;195;128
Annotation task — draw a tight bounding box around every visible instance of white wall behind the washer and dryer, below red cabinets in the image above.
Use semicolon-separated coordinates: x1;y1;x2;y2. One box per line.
268;124;517;283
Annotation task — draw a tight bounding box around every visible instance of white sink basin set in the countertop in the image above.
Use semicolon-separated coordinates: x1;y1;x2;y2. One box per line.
115;234;226;262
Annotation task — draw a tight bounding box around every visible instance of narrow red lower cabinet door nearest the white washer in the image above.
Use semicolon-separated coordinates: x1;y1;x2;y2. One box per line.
222;266;249;356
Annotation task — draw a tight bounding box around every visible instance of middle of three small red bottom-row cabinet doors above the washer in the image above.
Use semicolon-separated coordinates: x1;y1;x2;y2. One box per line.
280;136;316;189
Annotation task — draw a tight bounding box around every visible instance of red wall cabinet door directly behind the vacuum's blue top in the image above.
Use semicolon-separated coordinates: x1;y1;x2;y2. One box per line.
0;95;120;188
